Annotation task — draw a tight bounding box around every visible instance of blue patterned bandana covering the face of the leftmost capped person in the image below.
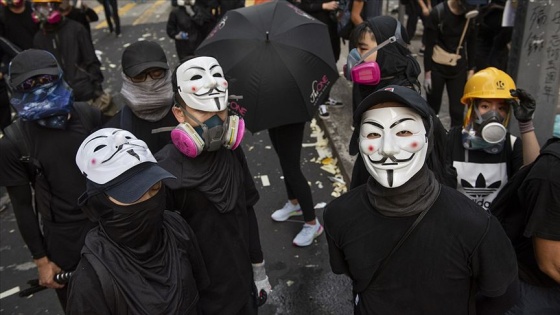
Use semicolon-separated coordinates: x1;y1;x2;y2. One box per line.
10;80;73;127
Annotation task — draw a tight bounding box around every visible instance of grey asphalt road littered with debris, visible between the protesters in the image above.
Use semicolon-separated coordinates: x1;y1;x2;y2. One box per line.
0;1;352;315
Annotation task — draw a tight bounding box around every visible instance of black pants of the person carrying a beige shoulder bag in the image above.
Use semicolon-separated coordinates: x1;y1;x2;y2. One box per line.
427;71;467;127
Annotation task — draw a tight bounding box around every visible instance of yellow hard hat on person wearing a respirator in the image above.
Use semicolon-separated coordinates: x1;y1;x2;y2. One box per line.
461;67;516;105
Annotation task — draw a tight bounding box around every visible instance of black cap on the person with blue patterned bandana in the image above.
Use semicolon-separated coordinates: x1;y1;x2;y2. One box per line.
9;49;62;89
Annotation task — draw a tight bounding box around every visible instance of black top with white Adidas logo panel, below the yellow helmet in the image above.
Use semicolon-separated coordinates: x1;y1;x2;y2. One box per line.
446;127;523;209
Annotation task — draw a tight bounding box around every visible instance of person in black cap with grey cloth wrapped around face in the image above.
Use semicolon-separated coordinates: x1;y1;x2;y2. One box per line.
105;41;177;152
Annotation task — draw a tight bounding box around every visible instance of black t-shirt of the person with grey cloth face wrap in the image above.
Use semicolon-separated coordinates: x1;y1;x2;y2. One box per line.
104;98;178;154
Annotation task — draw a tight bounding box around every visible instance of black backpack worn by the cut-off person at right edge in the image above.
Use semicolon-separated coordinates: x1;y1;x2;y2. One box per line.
488;141;560;247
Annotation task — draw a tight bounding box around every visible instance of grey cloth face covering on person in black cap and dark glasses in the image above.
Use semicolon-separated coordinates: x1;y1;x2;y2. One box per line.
121;71;173;122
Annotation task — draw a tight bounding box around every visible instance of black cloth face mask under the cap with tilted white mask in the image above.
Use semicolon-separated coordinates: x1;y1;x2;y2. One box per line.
99;185;165;257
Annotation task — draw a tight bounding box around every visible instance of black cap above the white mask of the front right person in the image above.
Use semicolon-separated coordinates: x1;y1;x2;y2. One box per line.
354;85;434;126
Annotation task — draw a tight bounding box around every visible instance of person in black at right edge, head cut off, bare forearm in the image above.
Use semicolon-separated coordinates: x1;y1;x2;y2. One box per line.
498;136;560;315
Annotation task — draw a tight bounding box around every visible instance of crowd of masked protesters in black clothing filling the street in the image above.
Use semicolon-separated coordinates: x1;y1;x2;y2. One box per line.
0;0;560;315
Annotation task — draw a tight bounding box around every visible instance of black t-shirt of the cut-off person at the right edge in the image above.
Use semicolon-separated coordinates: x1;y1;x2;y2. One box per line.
515;143;560;287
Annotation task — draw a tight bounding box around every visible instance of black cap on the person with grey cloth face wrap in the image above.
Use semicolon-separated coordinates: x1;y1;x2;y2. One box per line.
121;40;169;77
